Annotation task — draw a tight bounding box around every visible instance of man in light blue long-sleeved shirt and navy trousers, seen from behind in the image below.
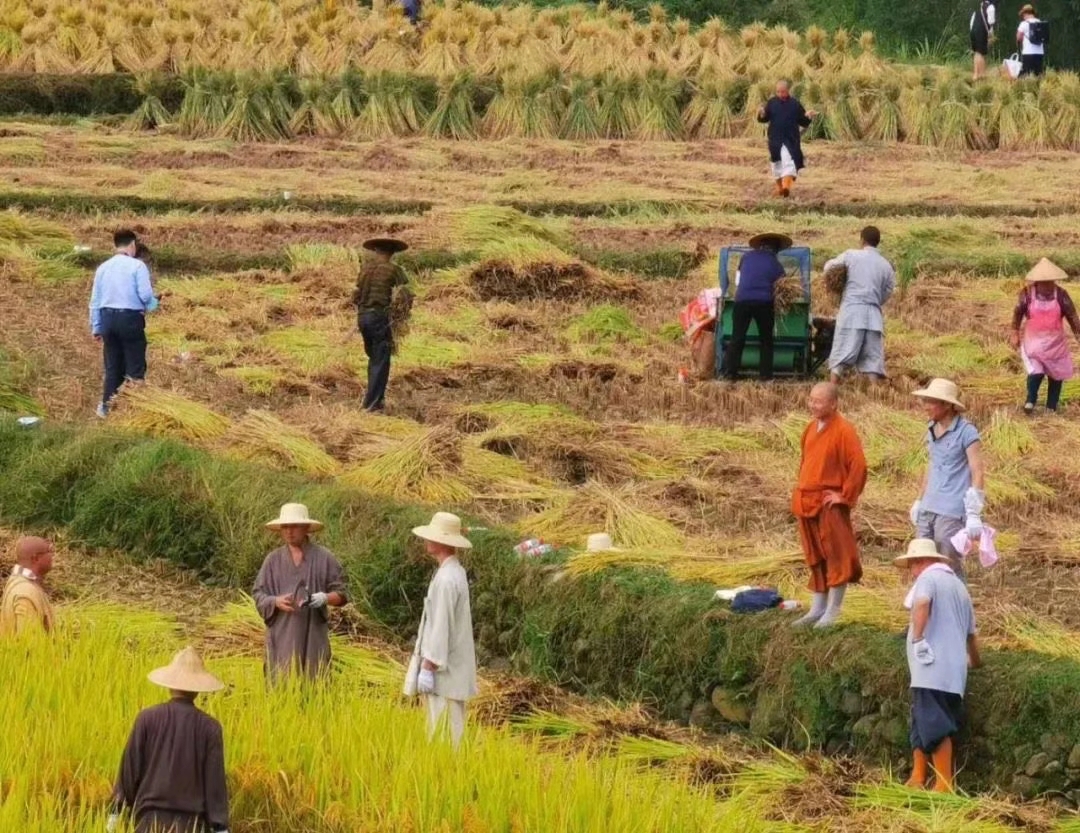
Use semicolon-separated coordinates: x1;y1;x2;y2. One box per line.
90;229;158;419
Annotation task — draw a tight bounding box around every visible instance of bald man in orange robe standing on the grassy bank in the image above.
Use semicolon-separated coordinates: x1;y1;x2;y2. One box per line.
792;382;866;628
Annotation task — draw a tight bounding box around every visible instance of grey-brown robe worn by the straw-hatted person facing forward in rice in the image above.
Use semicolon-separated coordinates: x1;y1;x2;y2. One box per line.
252;541;345;680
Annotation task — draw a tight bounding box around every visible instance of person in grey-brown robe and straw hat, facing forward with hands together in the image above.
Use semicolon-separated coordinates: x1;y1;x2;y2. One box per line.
252;503;347;682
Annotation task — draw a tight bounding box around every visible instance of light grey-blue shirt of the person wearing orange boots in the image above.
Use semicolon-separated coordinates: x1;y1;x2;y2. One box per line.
907;569;975;697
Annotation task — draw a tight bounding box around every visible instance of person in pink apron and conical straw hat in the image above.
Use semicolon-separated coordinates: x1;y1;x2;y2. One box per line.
1010;257;1080;414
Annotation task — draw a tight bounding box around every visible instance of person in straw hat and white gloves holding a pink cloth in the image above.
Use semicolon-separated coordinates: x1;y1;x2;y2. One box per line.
910;379;986;579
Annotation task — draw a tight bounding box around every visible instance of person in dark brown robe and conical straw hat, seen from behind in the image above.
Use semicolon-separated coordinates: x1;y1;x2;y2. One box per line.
106;647;229;833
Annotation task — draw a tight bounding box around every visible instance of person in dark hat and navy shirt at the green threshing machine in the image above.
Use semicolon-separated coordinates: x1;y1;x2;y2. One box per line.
724;233;792;381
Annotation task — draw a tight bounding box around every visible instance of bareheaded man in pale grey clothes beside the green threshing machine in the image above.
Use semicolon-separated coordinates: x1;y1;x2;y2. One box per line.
824;226;896;382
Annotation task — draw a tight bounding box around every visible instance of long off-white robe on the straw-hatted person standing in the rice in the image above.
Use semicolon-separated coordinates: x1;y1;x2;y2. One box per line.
405;556;476;701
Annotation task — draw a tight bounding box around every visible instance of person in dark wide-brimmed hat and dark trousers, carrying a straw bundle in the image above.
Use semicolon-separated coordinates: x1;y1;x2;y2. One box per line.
352;238;408;411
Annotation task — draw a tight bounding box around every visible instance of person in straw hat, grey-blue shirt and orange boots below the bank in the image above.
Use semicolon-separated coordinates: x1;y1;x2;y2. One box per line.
894;538;982;792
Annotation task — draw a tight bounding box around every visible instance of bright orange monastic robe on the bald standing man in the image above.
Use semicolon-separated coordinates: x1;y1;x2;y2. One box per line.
792;414;866;593
